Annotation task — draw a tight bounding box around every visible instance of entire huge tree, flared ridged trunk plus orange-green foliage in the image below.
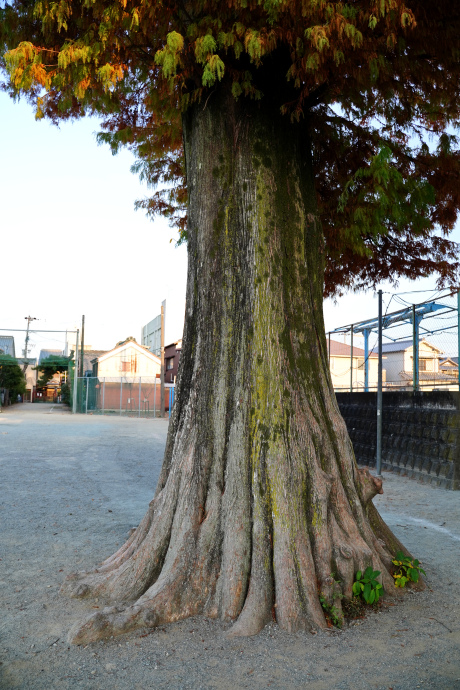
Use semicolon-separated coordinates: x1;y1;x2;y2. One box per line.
1;0;460;642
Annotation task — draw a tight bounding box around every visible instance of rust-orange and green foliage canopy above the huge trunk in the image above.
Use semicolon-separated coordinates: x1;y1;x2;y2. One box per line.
0;0;460;295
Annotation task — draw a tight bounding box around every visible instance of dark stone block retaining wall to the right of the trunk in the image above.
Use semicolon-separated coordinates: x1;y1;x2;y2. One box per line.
336;391;460;490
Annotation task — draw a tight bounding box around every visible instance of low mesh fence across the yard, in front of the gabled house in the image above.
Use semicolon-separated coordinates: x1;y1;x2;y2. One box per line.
76;376;174;417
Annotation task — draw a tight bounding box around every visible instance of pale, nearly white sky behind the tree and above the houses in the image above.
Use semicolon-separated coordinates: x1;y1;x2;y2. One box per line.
0;88;460;354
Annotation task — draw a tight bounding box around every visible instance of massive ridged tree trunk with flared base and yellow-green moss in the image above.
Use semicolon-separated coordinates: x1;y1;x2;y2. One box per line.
64;84;408;643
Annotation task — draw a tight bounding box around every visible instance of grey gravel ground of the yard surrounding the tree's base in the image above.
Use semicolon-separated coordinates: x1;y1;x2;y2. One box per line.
0;404;460;690
